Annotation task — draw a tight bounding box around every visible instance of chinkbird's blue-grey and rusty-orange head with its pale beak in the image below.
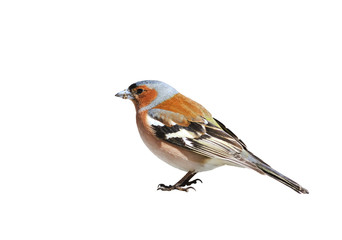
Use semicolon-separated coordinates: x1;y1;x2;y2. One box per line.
115;80;178;110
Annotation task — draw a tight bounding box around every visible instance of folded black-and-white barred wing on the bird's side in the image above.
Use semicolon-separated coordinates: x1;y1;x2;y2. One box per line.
147;109;260;172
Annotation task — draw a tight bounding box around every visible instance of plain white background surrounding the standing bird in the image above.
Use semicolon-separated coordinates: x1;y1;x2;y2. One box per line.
0;0;342;240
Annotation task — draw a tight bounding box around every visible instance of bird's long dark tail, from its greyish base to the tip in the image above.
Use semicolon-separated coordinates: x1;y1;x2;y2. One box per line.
243;151;309;194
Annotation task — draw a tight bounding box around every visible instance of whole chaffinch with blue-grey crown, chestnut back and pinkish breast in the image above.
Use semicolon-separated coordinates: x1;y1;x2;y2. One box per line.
115;80;309;194
